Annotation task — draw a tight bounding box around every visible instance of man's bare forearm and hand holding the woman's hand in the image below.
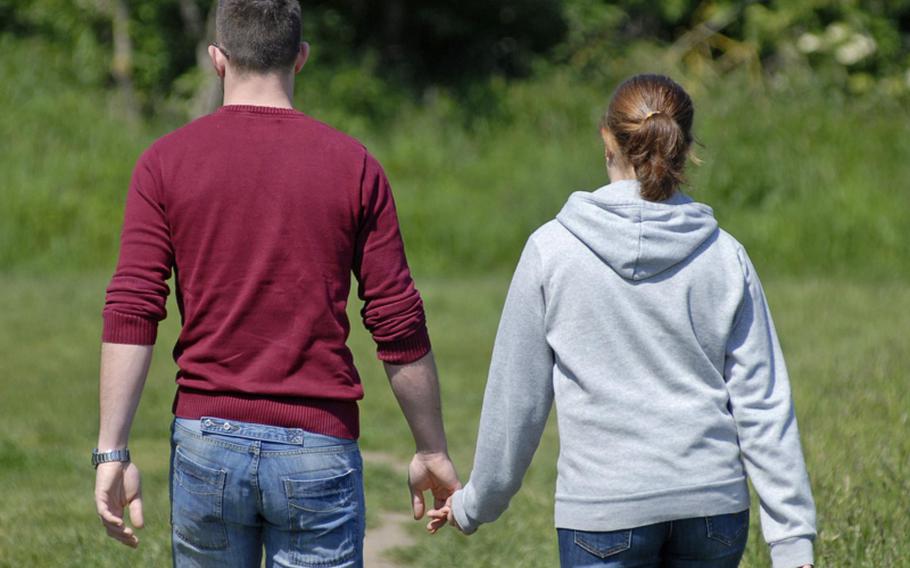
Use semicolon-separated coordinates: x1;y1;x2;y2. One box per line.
385;351;461;519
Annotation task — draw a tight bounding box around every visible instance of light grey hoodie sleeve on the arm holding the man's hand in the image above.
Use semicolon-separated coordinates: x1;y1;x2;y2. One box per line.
452;237;554;533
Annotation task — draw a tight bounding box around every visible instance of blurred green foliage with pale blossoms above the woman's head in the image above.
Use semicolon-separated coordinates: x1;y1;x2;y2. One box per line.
558;0;910;97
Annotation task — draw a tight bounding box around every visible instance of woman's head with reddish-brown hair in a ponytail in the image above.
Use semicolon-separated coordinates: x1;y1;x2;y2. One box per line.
600;75;695;201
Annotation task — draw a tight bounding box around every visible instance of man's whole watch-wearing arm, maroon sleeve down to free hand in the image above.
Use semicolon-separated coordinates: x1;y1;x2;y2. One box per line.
95;147;174;547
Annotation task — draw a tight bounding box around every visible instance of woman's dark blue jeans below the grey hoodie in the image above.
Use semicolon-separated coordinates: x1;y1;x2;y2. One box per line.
557;509;749;568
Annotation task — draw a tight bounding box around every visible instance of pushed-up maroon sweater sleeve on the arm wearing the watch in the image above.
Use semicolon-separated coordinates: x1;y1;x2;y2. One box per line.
102;145;174;345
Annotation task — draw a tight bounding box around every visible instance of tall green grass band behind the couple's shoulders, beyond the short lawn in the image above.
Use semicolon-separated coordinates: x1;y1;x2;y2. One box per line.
0;38;910;278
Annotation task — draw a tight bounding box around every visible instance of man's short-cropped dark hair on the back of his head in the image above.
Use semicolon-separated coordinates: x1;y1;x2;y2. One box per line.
215;0;300;73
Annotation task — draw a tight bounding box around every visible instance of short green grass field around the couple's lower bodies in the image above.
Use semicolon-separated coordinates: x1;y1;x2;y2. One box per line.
0;272;910;567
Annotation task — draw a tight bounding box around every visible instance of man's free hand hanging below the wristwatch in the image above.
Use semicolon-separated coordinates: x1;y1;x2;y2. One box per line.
95;462;144;548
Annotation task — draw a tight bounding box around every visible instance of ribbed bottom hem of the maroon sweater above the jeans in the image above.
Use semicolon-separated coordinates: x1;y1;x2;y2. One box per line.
173;387;360;440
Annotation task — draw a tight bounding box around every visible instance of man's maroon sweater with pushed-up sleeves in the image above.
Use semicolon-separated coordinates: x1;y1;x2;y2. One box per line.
103;105;430;438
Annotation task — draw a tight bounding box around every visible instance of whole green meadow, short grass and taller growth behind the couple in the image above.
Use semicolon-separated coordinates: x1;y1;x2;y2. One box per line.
0;28;910;567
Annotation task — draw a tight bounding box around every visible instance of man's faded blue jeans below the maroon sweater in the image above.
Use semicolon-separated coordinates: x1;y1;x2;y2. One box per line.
170;417;364;568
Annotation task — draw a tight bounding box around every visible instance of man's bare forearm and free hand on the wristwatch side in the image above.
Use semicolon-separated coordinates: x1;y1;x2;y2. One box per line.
95;343;152;548
